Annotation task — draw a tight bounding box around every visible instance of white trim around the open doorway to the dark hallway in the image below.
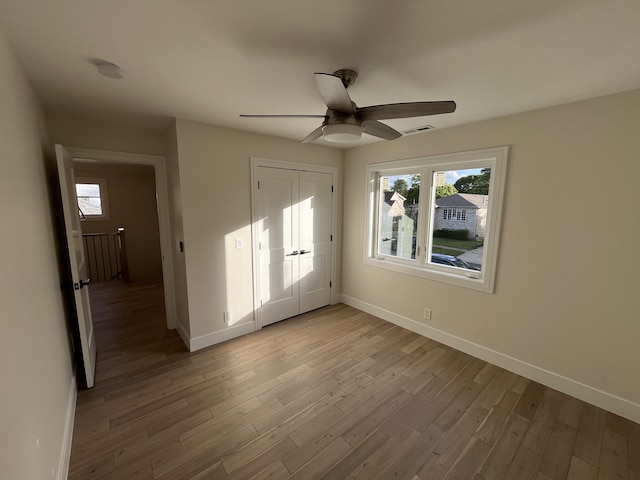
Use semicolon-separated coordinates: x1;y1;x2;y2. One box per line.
65;146;178;330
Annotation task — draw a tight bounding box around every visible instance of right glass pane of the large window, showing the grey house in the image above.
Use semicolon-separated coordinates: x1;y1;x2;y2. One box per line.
428;168;491;271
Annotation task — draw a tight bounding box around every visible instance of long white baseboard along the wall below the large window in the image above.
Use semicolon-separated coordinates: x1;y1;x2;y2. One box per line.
341;294;640;423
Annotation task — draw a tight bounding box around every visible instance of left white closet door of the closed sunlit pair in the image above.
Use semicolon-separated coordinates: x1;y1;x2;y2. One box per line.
255;167;300;326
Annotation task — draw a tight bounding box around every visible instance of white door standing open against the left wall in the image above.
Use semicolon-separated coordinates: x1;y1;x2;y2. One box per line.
56;145;96;388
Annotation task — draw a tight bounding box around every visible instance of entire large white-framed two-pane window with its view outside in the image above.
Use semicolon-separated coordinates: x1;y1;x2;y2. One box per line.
365;147;508;292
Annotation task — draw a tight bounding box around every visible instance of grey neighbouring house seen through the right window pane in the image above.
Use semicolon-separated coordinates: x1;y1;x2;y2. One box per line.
434;193;489;238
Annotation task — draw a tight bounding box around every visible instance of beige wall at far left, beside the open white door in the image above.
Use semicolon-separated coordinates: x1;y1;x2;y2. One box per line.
0;32;75;479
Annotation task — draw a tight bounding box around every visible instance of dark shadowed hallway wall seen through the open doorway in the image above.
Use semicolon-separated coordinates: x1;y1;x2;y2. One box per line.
74;163;162;281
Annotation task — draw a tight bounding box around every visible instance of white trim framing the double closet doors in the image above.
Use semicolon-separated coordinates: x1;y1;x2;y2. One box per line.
251;157;340;330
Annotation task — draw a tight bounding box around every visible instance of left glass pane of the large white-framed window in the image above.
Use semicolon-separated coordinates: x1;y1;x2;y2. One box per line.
377;173;420;260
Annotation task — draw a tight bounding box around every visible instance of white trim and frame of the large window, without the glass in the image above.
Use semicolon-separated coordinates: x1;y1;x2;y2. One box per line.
364;146;508;293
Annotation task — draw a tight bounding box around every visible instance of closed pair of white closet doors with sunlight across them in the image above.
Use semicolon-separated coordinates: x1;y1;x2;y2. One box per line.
254;166;332;326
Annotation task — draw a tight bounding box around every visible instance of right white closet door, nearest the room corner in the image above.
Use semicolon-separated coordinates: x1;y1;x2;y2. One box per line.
299;172;332;313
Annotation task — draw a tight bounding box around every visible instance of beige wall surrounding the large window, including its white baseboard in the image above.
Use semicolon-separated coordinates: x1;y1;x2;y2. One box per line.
342;91;640;421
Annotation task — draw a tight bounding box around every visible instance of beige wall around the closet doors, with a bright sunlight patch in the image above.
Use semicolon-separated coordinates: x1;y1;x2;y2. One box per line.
176;120;343;343
